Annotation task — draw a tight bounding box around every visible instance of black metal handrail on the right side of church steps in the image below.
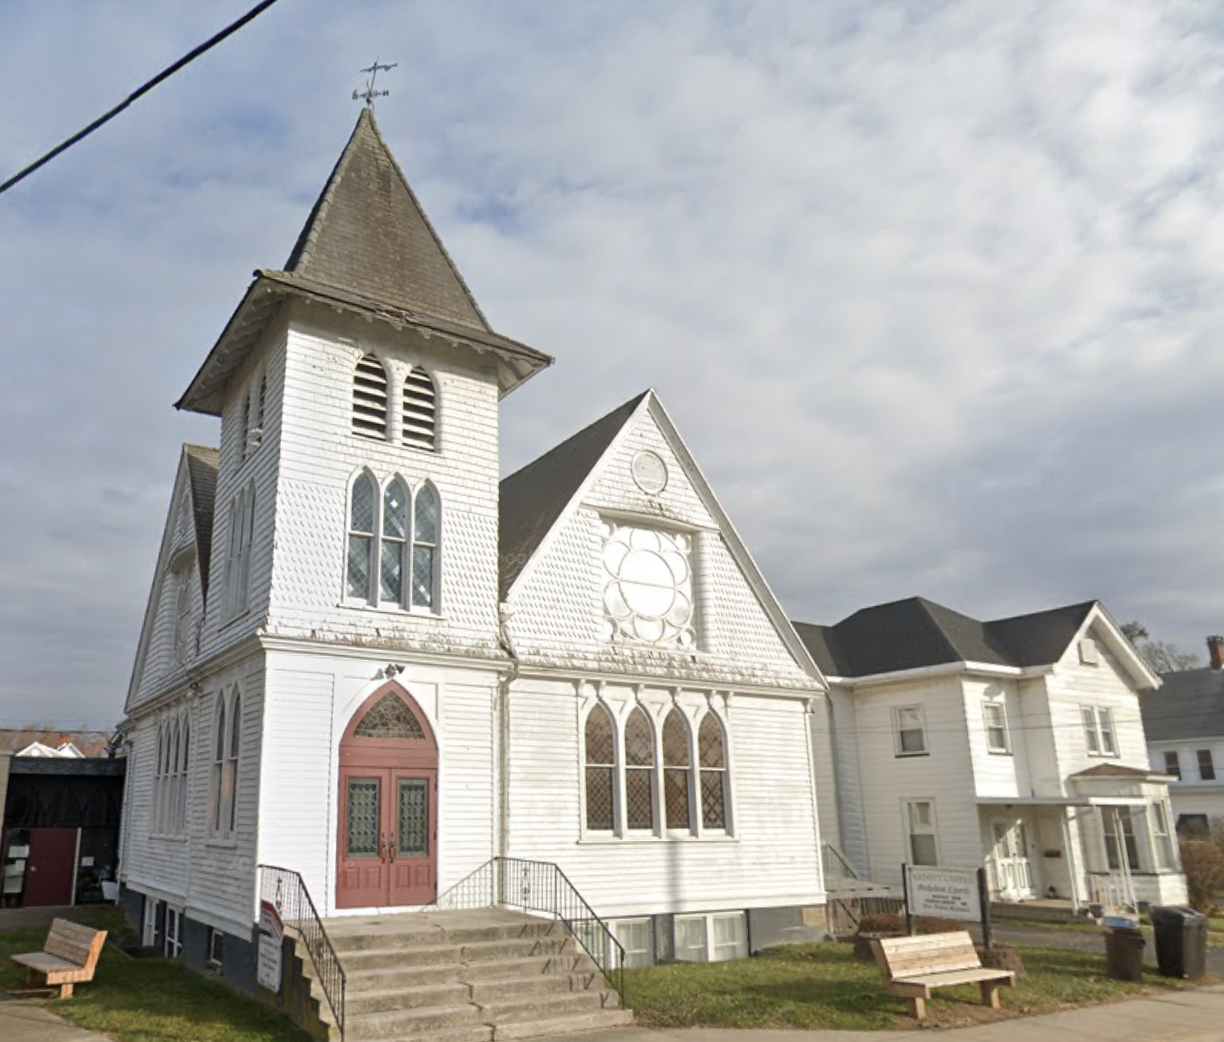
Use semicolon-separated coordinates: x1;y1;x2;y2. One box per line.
435;857;625;1008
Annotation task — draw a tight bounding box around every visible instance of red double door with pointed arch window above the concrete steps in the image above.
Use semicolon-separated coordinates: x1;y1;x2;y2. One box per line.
335;684;438;909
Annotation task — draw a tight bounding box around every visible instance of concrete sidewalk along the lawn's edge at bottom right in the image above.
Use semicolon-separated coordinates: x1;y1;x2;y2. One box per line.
583;984;1224;1042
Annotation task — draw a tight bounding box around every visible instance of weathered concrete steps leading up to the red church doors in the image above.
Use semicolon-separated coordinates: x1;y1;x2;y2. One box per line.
304;909;633;1042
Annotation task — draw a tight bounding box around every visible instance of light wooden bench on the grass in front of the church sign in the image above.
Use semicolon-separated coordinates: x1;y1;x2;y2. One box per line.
871;933;1016;1020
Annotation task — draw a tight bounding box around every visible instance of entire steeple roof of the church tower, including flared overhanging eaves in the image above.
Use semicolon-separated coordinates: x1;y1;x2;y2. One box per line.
175;109;552;415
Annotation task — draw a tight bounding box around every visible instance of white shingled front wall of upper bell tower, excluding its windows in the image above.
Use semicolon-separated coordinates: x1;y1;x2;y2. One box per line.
268;313;497;654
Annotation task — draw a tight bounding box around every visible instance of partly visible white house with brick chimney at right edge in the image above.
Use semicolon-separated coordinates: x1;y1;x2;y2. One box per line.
1142;637;1224;839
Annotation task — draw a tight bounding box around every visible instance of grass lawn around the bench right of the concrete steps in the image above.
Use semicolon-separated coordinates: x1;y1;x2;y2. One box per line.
625;942;1219;1030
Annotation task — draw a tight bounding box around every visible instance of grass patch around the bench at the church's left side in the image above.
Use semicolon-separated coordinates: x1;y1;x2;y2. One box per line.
0;907;310;1042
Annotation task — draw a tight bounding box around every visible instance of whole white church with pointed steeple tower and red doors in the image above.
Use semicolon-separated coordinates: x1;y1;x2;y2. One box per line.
121;110;830;988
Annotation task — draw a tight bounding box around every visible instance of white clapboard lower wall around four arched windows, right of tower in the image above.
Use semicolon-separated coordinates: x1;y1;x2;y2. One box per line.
508;680;824;916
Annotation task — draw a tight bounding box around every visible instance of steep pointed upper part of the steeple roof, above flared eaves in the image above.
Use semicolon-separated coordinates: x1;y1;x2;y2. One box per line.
285;108;490;331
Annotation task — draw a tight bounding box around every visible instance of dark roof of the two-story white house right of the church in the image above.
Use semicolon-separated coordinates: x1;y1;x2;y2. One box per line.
794;598;1097;677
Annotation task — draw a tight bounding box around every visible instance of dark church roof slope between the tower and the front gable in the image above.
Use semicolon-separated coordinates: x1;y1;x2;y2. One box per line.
499;391;650;600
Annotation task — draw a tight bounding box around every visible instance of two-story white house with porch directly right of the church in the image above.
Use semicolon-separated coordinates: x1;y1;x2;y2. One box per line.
797;598;1185;907
